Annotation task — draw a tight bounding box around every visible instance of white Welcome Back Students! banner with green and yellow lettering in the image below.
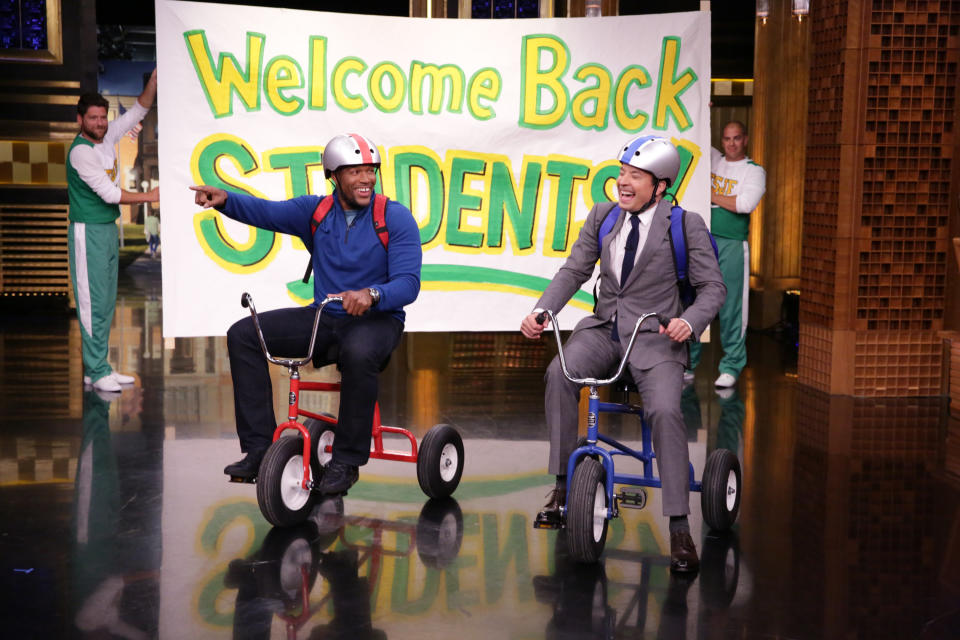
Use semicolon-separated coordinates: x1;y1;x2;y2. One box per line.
156;0;710;336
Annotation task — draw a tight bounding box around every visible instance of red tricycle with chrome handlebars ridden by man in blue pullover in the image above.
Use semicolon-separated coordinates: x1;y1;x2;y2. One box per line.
240;293;464;527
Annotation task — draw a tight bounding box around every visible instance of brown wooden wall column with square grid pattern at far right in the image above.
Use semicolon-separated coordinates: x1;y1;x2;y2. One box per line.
798;0;960;396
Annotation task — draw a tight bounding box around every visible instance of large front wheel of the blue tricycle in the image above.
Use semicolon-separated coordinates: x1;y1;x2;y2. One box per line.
567;457;609;563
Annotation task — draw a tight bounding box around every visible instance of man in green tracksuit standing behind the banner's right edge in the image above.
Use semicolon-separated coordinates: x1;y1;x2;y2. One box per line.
684;121;767;389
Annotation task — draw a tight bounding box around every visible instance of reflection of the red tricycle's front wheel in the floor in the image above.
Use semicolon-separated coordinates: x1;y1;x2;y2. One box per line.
256;522;320;604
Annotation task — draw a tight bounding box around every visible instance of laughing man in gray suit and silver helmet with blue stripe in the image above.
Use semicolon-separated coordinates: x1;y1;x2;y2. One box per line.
520;136;726;572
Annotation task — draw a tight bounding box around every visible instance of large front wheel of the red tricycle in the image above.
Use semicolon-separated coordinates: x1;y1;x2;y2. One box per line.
257;437;315;527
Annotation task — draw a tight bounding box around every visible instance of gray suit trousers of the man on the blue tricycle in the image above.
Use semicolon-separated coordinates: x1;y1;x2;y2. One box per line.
544;323;690;516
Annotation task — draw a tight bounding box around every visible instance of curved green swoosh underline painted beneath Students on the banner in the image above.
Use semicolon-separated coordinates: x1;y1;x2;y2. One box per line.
287;264;593;308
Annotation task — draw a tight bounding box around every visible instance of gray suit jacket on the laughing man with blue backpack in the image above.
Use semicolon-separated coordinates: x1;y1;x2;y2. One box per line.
537;200;727;369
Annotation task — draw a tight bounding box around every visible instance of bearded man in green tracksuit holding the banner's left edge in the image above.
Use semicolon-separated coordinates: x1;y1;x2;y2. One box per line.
67;70;160;392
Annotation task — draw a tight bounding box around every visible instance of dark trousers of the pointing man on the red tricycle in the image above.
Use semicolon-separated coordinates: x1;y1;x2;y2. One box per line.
227;307;403;466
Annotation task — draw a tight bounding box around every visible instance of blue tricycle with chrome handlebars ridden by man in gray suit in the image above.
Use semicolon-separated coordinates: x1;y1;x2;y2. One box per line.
537;310;741;562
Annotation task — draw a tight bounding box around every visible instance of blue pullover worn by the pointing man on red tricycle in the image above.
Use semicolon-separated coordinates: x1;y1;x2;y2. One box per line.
220;192;423;321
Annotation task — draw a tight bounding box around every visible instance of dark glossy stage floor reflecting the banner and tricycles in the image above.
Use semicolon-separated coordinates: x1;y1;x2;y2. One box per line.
0;259;960;640
